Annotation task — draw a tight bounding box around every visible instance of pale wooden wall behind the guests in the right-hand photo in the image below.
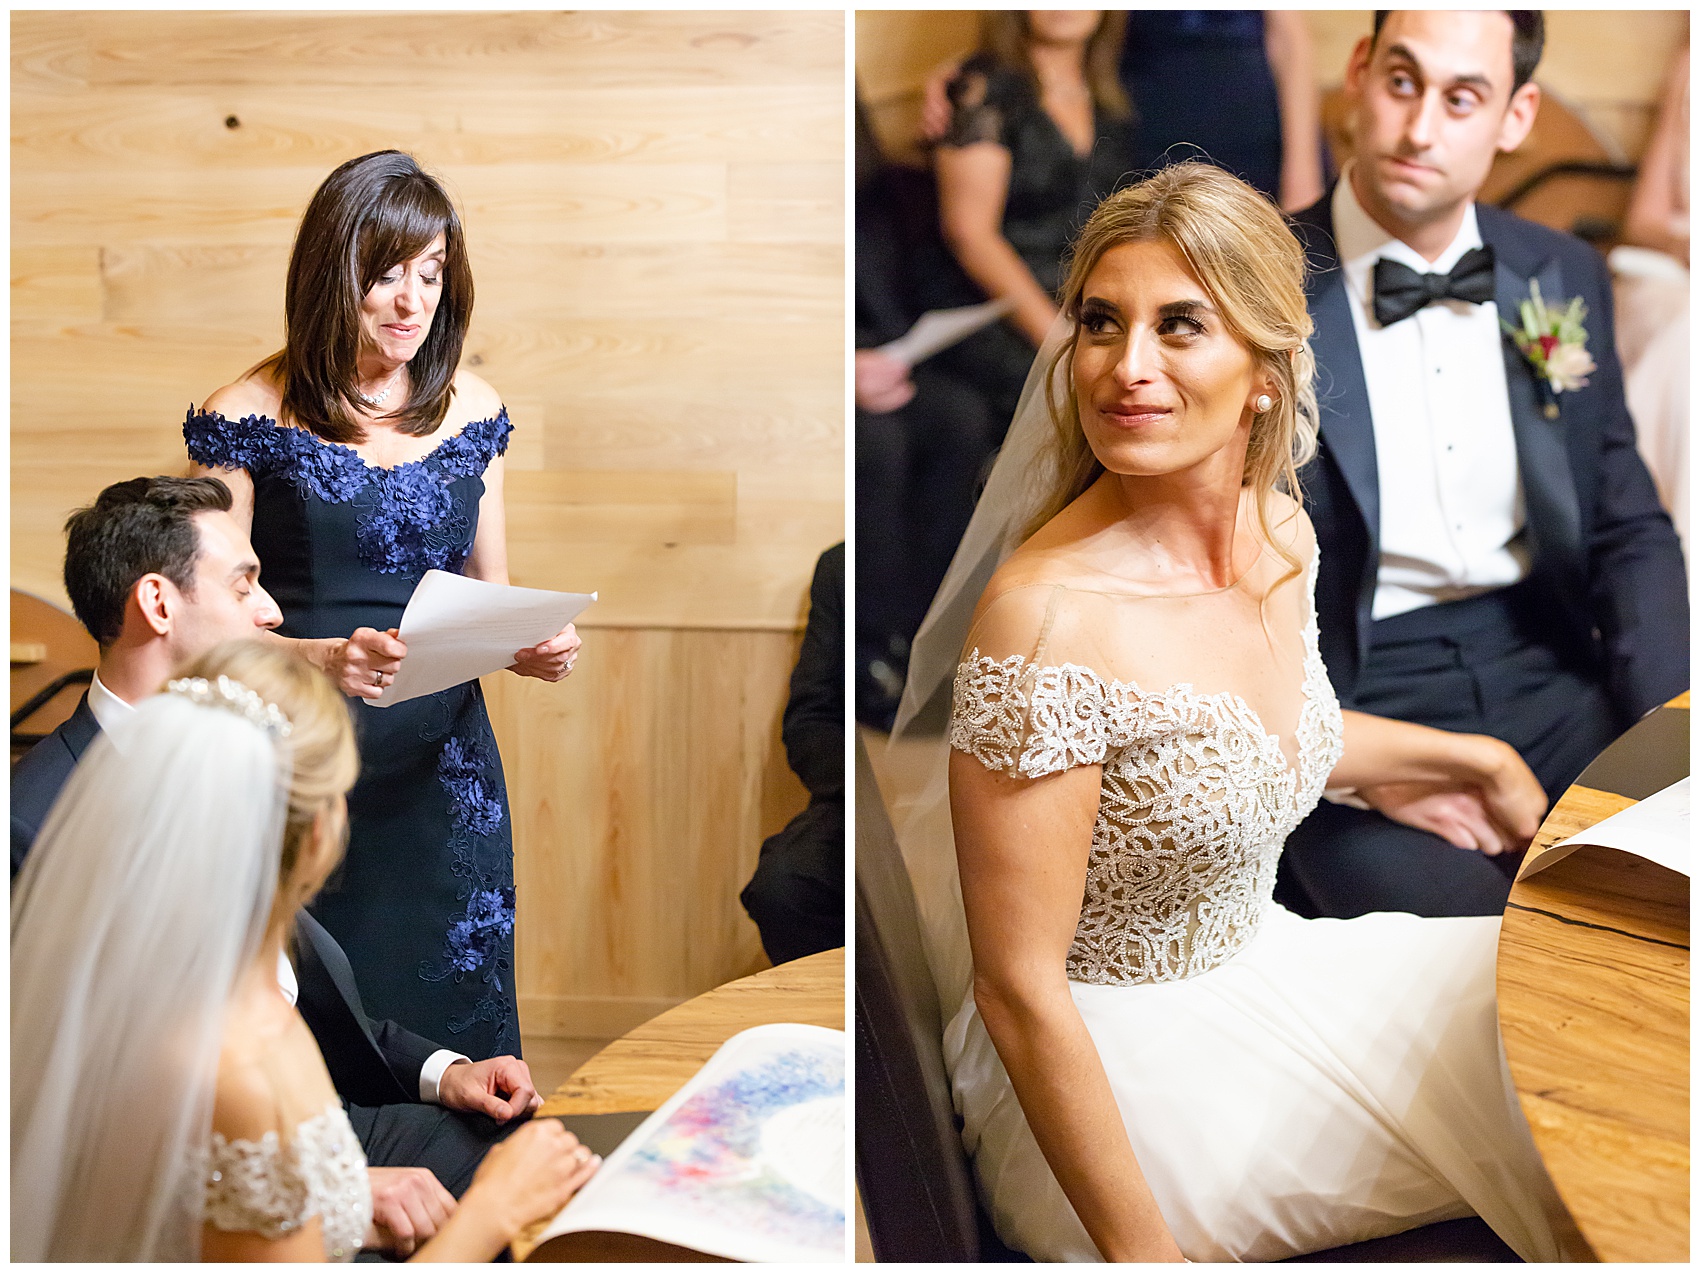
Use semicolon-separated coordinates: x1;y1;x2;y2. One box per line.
855;8;1688;163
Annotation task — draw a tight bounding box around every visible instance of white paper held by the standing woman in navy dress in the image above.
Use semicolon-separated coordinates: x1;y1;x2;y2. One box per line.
367;569;597;707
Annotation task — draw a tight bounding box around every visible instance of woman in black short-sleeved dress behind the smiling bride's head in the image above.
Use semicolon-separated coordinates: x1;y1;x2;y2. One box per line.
925;8;1132;428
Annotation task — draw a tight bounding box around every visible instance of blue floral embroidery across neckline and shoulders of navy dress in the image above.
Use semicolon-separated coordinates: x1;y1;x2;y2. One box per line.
184;408;513;574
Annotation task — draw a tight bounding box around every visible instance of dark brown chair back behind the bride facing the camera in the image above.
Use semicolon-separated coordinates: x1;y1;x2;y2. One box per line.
855;738;1022;1263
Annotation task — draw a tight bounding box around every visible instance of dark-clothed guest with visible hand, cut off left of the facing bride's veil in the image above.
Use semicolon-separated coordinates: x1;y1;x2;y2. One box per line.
855;97;1008;729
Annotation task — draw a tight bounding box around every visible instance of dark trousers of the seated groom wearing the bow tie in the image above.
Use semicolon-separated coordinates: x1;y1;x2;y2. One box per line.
1275;585;1618;919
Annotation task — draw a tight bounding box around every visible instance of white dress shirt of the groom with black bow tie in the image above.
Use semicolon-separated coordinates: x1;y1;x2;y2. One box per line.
1331;167;1528;619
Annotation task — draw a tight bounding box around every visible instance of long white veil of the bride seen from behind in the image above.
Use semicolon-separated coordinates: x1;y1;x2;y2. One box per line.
12;693;287;1261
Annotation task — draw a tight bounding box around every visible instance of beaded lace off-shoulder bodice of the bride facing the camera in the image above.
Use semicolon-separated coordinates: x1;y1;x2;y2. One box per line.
950;557;1341;984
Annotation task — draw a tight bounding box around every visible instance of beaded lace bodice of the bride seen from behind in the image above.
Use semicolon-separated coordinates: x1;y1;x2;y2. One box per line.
202;1103;372;1259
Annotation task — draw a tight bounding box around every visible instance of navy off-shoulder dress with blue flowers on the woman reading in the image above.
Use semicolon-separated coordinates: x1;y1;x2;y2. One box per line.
184;410;520;1061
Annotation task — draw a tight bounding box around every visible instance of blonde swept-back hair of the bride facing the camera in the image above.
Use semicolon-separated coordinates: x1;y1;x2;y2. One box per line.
1023;160;1318;581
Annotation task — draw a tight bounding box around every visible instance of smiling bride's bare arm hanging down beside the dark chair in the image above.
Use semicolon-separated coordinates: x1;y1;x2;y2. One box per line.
950;751;1182;1261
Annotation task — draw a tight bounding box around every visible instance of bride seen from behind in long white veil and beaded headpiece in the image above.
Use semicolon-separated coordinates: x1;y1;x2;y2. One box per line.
10;641;597;1261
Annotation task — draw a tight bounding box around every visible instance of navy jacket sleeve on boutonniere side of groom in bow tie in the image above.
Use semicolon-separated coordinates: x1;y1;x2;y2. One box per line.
1566;250;1688;726
